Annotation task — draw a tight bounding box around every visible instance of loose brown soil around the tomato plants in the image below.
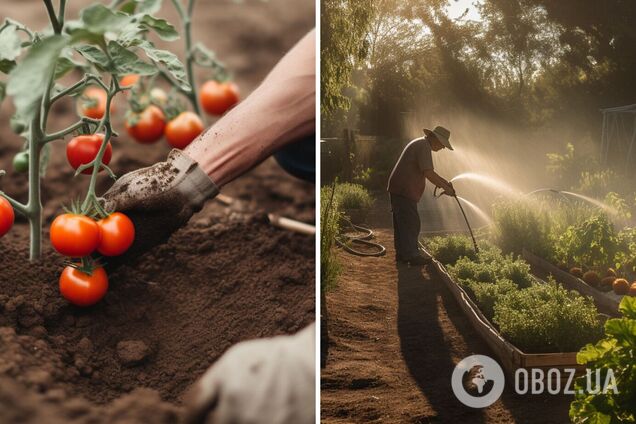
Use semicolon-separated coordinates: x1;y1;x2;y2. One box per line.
0;0;315;423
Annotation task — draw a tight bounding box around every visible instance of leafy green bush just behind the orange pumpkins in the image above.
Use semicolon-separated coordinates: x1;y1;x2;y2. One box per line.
555;214;619;269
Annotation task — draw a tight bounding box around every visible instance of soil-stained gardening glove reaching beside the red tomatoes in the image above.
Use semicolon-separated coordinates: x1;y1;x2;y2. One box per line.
104;149;219;268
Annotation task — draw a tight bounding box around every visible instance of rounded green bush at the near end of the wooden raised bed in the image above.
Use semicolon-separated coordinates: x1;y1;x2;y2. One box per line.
493;281;602;353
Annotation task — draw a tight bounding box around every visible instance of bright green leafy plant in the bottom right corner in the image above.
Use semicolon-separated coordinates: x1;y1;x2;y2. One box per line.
570;296;636;424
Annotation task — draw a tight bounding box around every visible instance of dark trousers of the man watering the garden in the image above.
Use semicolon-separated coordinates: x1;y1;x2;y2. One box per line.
390;194;420;260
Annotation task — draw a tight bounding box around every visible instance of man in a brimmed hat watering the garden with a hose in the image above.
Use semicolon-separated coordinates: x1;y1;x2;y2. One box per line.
387;127;455;265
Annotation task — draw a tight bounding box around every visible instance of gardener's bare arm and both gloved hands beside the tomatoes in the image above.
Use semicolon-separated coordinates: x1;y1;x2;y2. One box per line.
104;31;316;424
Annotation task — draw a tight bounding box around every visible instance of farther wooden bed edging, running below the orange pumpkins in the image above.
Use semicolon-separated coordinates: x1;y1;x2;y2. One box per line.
522;249;622;316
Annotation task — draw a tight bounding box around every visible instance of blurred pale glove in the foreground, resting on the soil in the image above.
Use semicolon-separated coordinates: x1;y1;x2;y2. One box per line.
185;324;316;424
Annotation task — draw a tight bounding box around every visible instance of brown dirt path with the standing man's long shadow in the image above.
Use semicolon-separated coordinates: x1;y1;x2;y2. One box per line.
321;229;571;424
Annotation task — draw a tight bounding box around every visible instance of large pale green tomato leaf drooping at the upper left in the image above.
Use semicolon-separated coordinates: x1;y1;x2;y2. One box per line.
7;35;68;119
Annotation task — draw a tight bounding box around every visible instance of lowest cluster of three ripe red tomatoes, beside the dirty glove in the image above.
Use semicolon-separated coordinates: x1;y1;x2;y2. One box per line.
50;212;135;306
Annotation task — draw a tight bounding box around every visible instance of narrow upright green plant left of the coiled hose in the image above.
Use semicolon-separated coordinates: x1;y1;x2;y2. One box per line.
320;183;342;290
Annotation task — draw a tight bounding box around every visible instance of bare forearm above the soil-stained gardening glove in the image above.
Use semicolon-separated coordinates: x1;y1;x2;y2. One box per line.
185;30;316;187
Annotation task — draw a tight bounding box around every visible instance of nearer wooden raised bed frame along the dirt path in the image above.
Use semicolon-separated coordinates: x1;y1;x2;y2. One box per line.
431;253;584;376
